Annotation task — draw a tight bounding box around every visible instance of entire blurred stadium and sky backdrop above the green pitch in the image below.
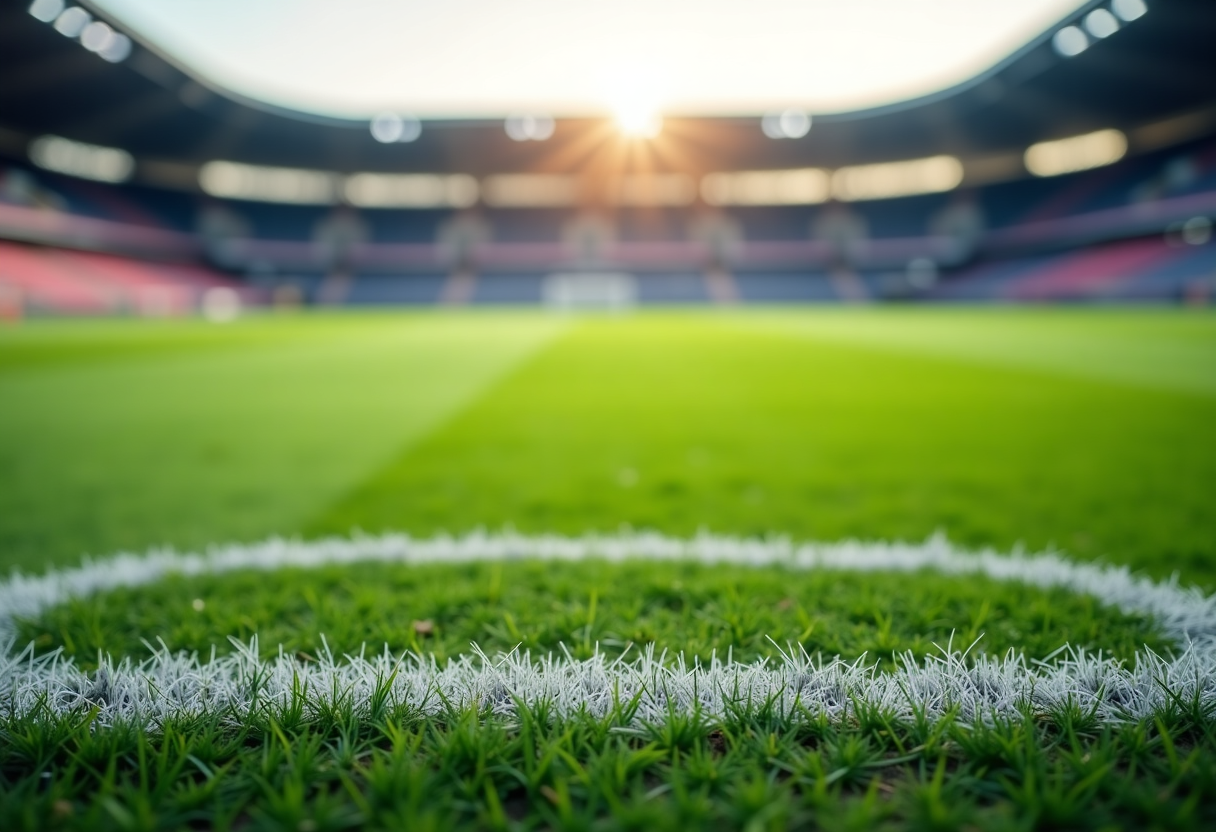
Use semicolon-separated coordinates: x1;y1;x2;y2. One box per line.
0;0;1216;320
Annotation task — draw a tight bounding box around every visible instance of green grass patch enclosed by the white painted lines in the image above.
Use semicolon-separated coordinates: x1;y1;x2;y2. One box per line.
21;561;1169;665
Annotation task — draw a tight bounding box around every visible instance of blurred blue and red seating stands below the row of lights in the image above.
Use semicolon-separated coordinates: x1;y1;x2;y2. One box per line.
0;141;1216;314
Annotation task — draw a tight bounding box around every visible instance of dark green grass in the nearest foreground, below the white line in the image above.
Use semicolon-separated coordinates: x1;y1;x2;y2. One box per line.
0;705;1216;832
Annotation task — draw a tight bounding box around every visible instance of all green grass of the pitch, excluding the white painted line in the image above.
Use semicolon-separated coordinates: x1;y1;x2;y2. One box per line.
0;309;1216;832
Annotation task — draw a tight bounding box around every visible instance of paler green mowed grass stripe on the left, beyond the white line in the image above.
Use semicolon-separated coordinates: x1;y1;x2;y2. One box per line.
0;314;564;569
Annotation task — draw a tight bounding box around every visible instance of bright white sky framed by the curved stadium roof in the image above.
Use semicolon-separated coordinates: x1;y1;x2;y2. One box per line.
95;0;1085;117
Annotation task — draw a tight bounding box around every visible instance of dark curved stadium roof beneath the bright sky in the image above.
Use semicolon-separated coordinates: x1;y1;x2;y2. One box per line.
0;0;1216;182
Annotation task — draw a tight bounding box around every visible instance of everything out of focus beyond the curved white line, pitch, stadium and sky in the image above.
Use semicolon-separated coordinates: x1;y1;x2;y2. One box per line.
0;0;1216;585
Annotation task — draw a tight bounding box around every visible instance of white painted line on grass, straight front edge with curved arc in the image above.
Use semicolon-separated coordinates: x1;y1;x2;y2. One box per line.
0;533;1216;725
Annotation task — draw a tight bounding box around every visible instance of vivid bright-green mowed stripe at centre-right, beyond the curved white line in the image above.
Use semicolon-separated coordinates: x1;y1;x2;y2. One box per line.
308;313;1216;586
